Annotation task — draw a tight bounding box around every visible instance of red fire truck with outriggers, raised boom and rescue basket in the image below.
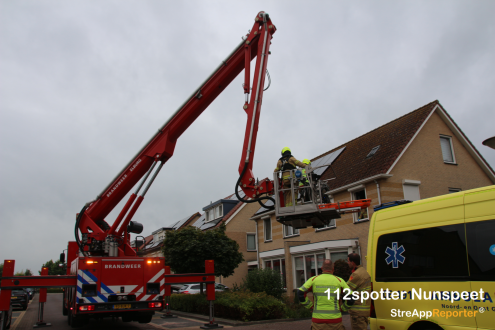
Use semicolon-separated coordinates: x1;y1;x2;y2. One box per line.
0;12;369;327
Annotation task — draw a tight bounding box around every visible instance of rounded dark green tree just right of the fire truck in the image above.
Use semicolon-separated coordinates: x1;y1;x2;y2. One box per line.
162;224;244;277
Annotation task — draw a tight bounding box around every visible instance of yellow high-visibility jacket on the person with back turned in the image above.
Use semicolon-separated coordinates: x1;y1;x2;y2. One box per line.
299;273;349;323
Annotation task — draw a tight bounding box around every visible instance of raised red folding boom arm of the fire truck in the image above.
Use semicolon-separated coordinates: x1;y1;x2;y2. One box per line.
75;12;276;256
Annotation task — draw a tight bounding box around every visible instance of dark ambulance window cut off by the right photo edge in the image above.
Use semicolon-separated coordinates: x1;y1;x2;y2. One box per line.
466;220;495;281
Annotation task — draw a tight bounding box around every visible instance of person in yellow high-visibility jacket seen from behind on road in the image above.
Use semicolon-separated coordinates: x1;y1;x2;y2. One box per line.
298;259;353;330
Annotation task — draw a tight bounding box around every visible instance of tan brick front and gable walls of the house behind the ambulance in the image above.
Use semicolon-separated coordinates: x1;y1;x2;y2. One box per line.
256;113;493;300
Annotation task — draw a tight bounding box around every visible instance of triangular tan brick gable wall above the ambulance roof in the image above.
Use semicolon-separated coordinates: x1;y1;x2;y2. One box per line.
390;112;493;201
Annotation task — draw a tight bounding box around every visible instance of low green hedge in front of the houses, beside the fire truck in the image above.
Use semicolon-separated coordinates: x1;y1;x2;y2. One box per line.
170;290;288;321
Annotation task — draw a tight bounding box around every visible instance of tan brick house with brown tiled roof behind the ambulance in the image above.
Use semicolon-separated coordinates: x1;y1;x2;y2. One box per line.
251;101;495;300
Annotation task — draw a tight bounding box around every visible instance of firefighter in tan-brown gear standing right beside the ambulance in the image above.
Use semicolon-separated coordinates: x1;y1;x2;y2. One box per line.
347;253;371;330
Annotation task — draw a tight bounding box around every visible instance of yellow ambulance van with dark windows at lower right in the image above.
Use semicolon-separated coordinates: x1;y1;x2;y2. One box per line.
367;186;495;330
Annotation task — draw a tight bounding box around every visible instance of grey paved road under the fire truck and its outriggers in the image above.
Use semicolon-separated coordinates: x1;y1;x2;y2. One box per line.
11;293;364;330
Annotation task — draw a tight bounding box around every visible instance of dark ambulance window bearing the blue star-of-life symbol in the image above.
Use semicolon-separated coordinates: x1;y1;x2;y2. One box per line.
376;224;468;282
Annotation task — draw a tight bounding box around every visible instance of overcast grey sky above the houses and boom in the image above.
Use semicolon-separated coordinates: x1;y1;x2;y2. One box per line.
0;0;495;273
